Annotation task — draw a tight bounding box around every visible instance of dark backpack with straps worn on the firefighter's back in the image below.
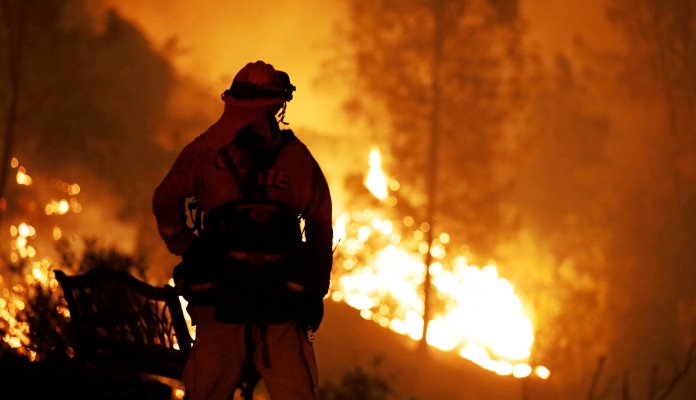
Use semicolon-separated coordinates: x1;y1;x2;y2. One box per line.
202;127;304;324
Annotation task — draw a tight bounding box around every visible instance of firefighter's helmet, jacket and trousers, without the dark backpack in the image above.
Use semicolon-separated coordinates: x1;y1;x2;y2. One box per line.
153;61;332;400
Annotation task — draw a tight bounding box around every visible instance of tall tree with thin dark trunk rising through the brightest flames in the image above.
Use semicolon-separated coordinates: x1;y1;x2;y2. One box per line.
340;0;519;344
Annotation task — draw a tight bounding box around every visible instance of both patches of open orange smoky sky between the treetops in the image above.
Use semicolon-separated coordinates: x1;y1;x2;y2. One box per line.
103;0;617;133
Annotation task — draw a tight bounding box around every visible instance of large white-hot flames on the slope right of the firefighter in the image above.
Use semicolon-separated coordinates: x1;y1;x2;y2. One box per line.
330;149;550;379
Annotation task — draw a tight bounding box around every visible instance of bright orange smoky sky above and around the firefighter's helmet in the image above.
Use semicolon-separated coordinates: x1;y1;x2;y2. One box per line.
104;0;350;133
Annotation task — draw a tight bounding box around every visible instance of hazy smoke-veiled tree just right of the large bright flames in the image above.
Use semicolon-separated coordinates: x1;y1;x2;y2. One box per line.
498;50;613;384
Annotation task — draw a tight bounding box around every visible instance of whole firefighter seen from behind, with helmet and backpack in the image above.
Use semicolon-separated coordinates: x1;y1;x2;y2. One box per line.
153;61;332;400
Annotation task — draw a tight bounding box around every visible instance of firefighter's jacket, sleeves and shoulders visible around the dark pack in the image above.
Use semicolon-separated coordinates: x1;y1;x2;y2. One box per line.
153;123;332;310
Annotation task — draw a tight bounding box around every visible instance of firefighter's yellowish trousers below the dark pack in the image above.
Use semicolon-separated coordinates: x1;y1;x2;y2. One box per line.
183;306;317;400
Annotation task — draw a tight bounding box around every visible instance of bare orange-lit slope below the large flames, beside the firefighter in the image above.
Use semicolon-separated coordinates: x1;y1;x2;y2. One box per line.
315;302;538;400
